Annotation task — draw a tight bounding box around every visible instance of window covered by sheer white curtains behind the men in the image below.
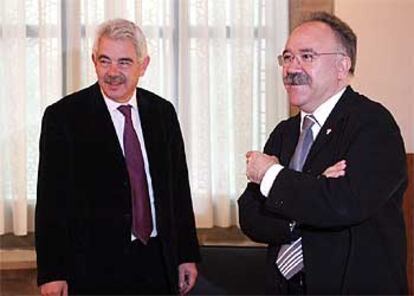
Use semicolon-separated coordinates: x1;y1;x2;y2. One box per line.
0;0;288;234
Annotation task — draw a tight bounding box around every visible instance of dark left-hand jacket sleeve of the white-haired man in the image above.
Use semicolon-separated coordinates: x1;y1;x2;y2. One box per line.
35;107;69;285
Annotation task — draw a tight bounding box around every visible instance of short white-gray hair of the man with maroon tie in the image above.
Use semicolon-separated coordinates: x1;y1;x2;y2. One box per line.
92;18;148;62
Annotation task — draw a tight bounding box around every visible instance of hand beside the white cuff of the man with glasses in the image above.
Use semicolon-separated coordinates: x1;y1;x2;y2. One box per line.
246;151;279;184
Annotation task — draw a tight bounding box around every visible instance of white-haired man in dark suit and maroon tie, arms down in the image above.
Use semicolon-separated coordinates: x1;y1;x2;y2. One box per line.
35;19;200;295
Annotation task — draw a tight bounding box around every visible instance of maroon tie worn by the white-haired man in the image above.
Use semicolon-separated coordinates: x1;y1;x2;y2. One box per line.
118;105;152;244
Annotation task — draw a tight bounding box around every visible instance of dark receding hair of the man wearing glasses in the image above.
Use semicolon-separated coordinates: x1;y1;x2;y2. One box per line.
301;11;357;74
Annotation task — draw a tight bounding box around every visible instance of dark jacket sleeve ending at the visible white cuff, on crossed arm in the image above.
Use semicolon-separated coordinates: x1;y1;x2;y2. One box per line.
266;104;407;229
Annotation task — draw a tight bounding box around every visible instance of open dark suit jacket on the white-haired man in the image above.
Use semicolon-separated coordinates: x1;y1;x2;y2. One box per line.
36;84;200;289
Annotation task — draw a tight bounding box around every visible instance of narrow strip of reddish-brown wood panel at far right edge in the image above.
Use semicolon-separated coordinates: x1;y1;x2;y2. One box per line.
404;153;414;295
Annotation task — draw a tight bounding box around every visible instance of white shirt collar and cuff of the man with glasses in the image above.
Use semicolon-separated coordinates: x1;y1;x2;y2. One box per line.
260;87;345;197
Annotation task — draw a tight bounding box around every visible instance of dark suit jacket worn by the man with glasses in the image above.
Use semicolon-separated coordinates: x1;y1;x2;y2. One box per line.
239;87;407;294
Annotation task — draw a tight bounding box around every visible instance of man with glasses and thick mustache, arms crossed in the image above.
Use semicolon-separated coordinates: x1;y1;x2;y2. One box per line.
239;13;407;294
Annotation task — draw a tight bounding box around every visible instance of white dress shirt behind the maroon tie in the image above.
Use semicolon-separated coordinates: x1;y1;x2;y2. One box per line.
101;89;157;240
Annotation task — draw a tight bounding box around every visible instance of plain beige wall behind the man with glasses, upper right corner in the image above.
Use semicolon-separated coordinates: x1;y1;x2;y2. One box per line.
334;0;414;153
